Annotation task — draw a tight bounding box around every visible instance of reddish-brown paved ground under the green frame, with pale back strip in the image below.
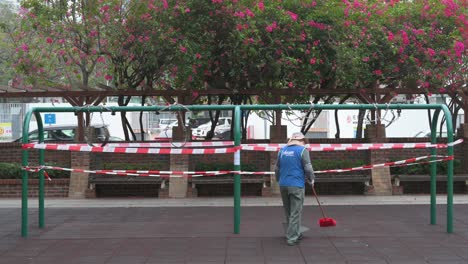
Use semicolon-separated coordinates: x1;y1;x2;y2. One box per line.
0;195;468;264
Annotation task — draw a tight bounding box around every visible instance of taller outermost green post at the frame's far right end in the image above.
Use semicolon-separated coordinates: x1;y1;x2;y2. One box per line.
442;105;454;233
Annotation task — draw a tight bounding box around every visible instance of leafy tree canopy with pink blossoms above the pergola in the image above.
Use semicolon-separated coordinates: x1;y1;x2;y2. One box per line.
8;0;466;99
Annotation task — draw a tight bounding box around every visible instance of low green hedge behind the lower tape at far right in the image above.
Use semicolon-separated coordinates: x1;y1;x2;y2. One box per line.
390;159;462;175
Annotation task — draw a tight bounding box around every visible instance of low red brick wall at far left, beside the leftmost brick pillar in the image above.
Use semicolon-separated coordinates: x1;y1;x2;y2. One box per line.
0;179;69;198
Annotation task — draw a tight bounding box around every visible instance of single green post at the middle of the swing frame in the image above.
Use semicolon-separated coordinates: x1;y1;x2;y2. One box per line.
234;106;241;234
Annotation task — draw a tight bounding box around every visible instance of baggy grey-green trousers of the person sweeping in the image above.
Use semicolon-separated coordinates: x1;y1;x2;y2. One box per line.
280;187;305;242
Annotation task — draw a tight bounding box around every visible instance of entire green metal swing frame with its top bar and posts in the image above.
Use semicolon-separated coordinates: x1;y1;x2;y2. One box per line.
21;104;454;237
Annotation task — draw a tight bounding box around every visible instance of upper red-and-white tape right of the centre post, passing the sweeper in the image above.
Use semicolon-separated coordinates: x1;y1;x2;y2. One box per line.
241;139;463;151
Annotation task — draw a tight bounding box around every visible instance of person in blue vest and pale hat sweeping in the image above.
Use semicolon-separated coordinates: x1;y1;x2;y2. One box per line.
275;132;315;246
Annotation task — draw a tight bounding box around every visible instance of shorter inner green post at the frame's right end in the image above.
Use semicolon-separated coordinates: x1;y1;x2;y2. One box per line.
430;109;440;225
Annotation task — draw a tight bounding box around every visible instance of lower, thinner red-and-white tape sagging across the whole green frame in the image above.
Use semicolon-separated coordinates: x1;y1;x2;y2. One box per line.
23;155;454;178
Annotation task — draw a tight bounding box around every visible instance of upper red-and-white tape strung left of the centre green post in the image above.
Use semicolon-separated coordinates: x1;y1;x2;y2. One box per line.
23;143;240;154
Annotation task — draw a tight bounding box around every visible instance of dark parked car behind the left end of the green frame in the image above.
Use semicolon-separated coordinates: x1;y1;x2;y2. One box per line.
15;125;123;142
